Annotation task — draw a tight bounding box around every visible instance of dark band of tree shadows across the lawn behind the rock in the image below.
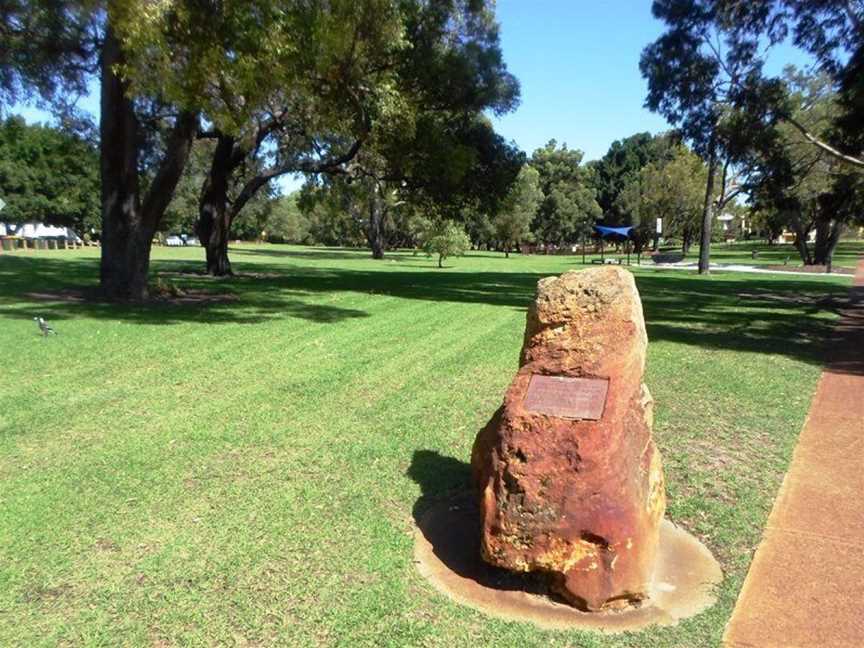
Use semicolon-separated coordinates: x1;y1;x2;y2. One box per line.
0;249;848;365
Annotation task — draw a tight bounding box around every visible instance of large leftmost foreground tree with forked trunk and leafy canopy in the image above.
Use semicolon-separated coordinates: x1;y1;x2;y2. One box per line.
101;0;305;299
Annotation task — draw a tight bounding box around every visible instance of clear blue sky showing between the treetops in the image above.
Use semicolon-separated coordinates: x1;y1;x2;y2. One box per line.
10;0;807;190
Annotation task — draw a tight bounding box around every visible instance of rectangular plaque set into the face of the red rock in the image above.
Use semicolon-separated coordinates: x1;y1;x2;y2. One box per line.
522;374;609;421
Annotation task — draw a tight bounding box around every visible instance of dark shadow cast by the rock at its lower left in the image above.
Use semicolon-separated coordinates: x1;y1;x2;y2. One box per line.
406;450;550;596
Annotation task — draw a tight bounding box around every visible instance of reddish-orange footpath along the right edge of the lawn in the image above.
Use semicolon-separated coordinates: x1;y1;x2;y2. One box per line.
723;259;864;648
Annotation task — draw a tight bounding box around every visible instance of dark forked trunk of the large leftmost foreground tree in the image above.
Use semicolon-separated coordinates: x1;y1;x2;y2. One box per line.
99;29;198;301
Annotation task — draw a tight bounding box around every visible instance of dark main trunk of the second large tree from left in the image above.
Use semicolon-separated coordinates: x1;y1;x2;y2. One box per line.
198;135;235;277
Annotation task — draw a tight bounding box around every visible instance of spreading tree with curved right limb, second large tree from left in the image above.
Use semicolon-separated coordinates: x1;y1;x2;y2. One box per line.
193;0;518;274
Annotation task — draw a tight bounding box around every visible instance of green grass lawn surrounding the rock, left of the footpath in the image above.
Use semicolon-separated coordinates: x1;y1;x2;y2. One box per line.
0;245;849;648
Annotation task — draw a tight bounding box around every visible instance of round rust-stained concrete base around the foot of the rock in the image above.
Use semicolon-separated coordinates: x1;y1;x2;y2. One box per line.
414;495;723;633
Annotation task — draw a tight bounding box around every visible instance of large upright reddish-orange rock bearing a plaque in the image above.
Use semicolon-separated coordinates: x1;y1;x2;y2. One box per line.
471;266;666;611
